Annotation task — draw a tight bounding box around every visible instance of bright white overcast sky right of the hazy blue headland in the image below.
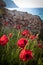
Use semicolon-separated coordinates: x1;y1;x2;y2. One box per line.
12;0;43;8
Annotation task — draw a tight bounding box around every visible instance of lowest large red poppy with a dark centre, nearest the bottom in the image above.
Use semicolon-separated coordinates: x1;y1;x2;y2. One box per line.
19;49;33;61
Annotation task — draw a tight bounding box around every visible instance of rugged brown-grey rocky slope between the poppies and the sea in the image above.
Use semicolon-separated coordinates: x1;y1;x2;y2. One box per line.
2;9;42;32
